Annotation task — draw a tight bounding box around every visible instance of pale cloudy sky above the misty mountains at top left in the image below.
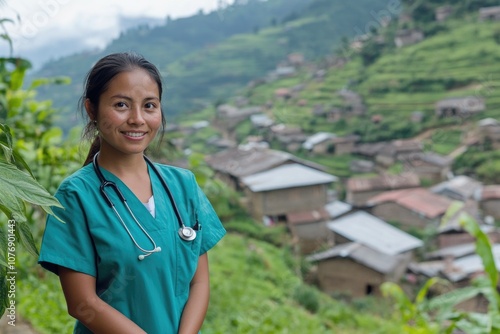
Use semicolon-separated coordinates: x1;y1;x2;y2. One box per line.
0;0;232;67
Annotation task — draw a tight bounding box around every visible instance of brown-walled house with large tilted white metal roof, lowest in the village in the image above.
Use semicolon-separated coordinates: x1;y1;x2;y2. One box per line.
307;211;423;297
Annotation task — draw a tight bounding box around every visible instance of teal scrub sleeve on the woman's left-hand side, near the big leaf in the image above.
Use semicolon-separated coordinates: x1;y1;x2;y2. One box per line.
38;182;96;277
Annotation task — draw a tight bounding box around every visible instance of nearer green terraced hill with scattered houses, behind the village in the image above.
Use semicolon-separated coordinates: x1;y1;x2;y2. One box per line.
179;1;500;184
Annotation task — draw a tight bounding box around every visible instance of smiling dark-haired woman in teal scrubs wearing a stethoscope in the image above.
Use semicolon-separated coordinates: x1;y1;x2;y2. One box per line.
39;53;225;334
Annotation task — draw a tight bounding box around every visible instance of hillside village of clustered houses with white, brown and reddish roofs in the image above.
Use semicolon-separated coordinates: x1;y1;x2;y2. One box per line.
161;6;500;310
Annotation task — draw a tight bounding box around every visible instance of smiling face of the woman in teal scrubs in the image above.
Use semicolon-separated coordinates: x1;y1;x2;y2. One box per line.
85;68;162;159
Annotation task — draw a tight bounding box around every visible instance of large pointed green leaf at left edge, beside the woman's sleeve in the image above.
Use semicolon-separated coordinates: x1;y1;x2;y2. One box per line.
0;162;62;207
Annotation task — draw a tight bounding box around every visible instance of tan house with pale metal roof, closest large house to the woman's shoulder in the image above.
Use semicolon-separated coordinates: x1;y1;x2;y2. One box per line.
241;163;338;221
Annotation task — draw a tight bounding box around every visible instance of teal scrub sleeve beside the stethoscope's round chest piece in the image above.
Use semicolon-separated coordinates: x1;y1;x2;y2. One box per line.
193;176;226;255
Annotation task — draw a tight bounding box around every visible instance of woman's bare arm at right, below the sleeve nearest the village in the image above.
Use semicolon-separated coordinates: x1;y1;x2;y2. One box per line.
179;253;210;334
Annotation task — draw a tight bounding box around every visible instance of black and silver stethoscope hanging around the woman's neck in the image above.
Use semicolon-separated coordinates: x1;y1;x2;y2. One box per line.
92;152;201;261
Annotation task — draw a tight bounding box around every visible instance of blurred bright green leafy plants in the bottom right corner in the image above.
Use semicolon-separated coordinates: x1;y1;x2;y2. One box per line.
381;203;500;334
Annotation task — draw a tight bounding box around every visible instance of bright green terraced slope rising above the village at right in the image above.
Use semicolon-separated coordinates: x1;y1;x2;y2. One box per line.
194;7;500;183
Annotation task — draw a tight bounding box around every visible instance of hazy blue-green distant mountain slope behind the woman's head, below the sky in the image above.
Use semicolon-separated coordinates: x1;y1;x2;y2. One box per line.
32;0;386;128
